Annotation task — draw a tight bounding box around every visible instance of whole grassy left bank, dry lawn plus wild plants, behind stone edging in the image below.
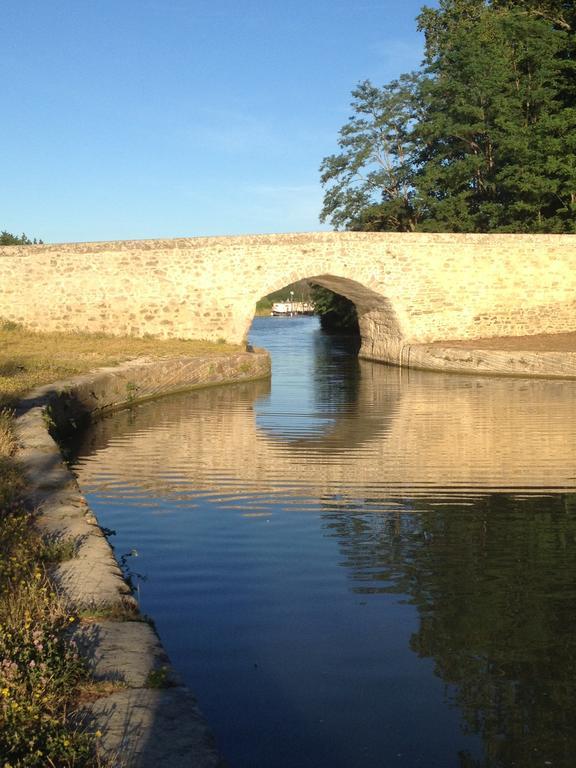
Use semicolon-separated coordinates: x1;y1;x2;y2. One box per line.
0;323;238;768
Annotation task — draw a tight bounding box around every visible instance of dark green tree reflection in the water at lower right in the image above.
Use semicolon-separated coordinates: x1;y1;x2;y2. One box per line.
324;494;576;768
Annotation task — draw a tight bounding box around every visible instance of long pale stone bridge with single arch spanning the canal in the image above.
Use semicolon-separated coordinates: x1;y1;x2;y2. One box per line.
0;232;576;362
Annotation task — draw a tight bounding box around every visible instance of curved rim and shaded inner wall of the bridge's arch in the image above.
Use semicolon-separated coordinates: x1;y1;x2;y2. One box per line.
249;272;404;359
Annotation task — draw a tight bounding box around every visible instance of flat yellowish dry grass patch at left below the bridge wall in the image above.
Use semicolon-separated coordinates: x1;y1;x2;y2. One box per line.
0;321;240;412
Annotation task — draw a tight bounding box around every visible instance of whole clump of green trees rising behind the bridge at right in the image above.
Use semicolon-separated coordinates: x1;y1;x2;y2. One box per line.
321;0;576;233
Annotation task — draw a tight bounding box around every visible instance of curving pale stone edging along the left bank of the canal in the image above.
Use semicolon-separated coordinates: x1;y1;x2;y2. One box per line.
15;350;270;768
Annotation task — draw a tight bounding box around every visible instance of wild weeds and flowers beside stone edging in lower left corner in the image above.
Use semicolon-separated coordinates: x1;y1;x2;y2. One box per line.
0;500;97;768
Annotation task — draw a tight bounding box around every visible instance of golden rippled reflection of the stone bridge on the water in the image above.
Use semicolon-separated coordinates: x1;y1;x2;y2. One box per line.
74;361;576;498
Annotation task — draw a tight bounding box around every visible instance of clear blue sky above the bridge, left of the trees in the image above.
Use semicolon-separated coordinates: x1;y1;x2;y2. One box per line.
0;0;435;242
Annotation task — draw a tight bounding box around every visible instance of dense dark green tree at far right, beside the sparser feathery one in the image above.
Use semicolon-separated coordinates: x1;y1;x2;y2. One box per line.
415;0;576;232
